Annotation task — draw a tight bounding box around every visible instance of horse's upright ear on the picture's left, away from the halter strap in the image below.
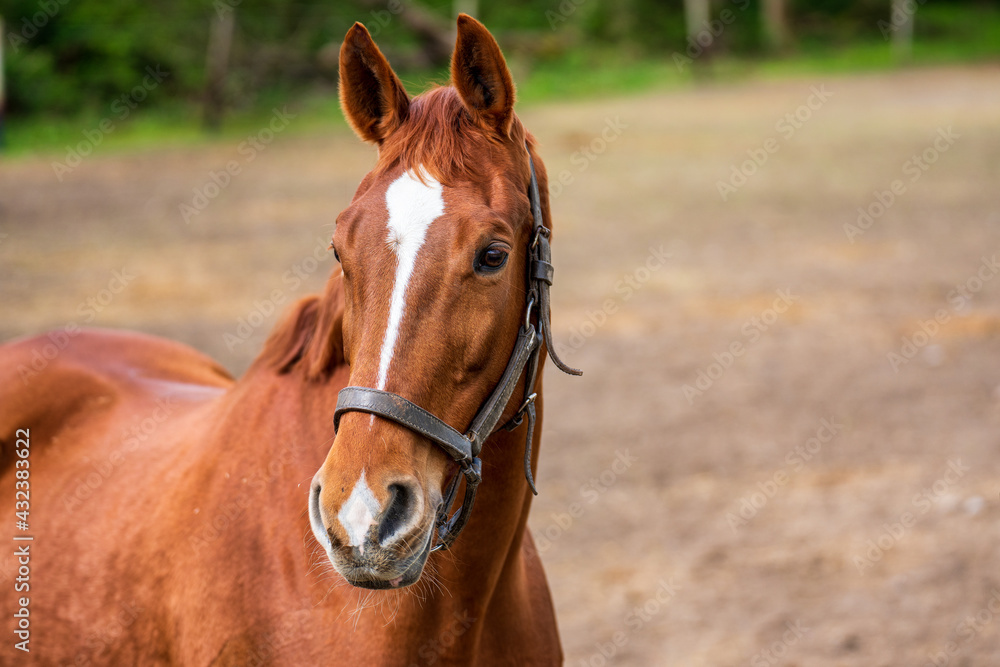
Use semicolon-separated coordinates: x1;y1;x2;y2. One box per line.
340;23;410;144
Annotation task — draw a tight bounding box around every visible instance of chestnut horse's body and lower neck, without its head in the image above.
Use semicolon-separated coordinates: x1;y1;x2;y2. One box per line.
0;310;559;665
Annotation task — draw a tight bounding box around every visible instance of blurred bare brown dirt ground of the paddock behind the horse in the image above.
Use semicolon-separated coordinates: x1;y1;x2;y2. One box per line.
0;66;1000;667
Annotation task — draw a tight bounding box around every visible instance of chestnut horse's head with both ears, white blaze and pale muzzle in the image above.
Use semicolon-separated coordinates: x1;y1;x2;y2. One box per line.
310;15;572;588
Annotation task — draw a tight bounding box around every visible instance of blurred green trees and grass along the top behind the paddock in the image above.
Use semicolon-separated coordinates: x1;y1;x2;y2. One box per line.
0;0;1000;139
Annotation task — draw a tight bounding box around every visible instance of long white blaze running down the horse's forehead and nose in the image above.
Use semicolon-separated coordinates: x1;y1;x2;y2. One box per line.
373;171;444;392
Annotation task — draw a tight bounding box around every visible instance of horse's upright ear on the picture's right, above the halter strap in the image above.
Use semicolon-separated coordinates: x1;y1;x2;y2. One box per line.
451;14;514;137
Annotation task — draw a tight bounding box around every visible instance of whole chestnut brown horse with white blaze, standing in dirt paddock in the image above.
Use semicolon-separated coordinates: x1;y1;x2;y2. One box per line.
0;15;580;666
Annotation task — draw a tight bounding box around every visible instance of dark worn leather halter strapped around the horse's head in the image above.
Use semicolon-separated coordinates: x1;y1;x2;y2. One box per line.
333;152;583;551
